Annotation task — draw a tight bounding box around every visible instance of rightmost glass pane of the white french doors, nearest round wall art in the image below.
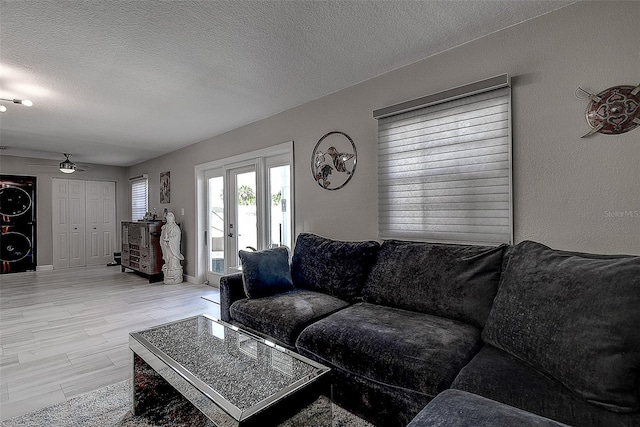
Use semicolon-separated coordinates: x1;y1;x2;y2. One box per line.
269;165;291;248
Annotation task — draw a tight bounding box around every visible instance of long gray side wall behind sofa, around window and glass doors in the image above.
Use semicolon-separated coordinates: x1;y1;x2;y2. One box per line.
129;2;640;275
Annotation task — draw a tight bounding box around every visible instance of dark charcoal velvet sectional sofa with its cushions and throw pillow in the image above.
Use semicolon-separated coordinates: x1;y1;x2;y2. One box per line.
220;233;640;427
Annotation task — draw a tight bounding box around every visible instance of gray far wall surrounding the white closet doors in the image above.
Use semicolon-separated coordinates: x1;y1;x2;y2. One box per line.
0;155;131;267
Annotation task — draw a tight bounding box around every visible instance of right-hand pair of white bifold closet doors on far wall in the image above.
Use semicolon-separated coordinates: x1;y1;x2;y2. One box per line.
85;181;116;265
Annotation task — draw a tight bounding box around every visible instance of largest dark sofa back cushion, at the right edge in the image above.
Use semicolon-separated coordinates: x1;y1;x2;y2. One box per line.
483;241;640;412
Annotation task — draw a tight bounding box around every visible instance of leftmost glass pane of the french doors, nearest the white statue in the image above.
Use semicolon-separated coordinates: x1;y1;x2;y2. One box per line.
207;176;224;274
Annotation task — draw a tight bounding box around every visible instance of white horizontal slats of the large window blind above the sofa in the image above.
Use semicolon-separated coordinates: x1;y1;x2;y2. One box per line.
378;88;512;244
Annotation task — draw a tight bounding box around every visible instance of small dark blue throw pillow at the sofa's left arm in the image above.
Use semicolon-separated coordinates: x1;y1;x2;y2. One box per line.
239;247;293;298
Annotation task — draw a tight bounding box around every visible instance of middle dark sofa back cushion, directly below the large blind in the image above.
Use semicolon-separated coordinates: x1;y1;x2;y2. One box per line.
363;240;505;328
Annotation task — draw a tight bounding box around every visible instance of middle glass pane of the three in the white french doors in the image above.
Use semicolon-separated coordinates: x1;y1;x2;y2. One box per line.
235;171;258;265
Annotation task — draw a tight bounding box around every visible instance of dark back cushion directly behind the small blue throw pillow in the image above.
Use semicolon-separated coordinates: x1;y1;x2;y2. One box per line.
291;233;380;302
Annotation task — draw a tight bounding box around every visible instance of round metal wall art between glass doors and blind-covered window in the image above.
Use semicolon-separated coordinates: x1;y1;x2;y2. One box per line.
311;131;357;190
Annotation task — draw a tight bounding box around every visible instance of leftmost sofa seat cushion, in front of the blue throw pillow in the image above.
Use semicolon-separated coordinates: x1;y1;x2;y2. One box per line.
230;289;349;347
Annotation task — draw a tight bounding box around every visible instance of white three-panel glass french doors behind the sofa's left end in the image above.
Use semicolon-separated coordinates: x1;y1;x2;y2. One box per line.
203;155;293;282
